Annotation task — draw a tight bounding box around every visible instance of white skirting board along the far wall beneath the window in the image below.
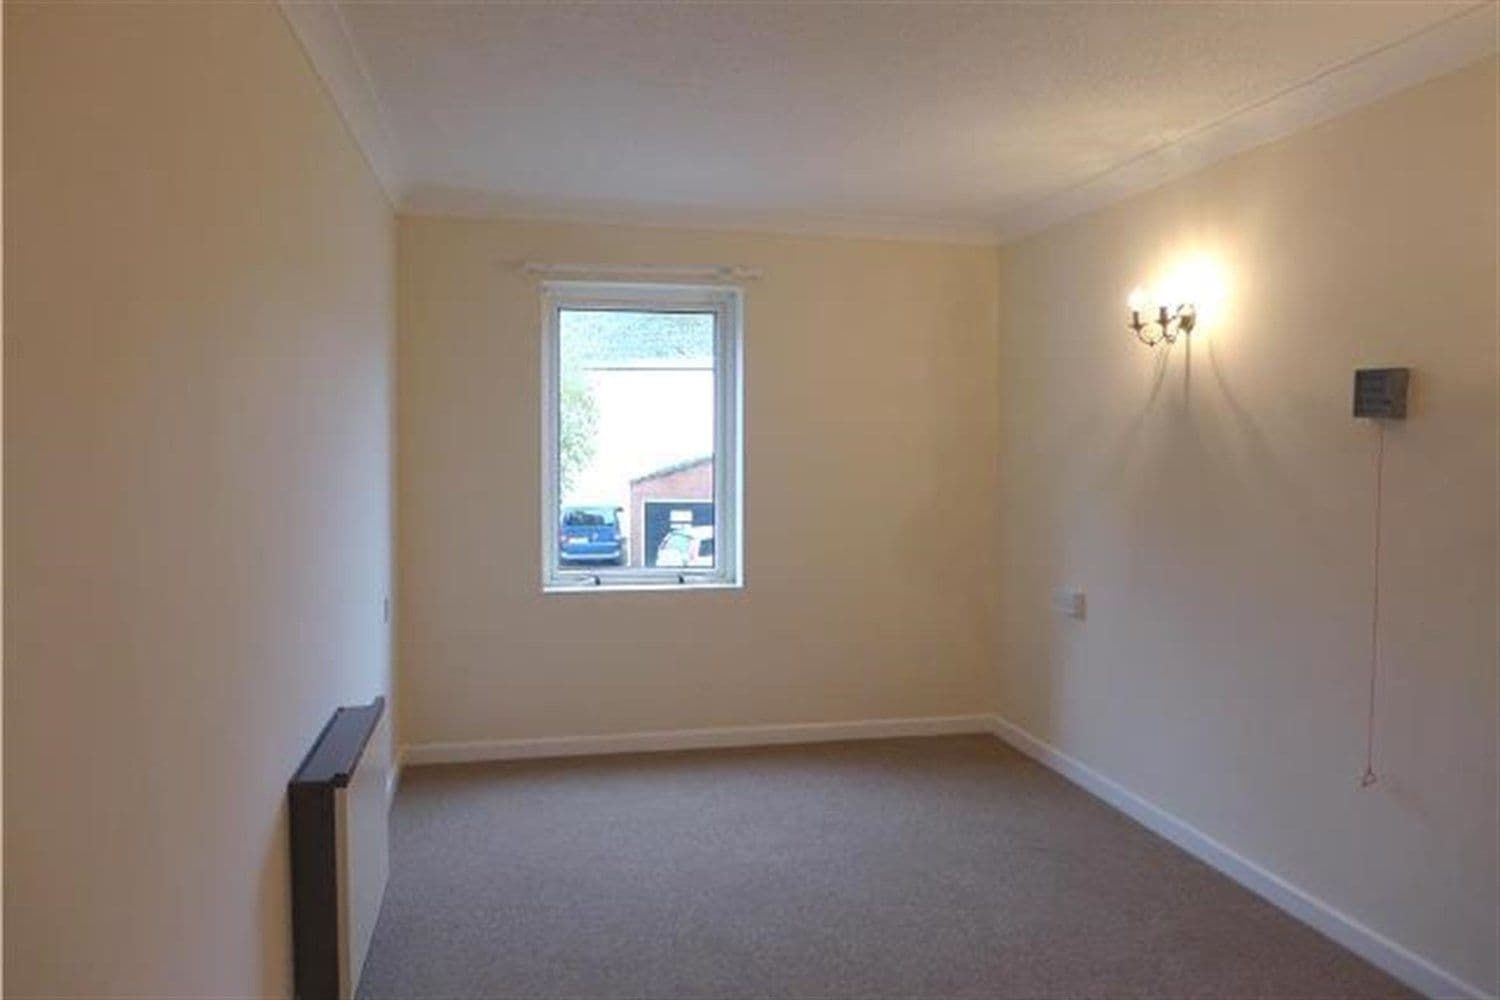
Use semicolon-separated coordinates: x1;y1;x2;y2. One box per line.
401;715;995;766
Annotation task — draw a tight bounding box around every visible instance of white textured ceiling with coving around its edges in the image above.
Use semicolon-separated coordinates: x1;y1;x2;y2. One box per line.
284;0;1496;238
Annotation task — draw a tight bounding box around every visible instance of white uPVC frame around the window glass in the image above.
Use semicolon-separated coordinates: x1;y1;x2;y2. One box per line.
542;280;744;594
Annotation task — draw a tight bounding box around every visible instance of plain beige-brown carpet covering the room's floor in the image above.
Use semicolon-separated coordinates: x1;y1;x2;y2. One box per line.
360;736;1412;1000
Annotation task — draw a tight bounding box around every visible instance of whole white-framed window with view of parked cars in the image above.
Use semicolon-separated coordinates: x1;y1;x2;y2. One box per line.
542;282;741;591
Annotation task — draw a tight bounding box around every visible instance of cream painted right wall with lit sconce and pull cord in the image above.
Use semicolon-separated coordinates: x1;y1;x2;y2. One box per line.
990;60;1500;993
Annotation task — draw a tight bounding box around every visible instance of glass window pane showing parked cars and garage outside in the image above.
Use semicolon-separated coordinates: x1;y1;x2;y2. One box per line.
558;309;716;570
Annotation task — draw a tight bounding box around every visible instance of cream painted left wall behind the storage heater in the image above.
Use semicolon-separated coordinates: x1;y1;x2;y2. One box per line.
5;3;395;997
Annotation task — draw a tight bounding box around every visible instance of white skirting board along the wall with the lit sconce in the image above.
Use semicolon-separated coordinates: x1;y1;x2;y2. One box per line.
995;718;1490;1000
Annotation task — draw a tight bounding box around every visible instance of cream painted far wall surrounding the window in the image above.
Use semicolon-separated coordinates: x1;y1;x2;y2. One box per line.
398;217;998;744
